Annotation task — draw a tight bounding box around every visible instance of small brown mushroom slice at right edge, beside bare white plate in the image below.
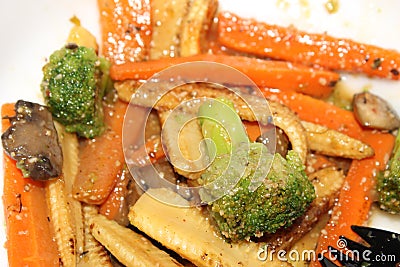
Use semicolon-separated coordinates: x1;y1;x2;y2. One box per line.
353;92;400;130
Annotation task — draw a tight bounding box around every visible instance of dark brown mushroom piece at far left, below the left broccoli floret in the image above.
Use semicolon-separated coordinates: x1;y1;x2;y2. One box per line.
1;100;63;180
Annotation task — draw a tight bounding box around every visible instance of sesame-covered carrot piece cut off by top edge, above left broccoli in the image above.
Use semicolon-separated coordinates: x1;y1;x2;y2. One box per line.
97;0;151;64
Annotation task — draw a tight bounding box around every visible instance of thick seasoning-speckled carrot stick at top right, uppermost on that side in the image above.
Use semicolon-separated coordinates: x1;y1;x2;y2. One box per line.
218;12;400;80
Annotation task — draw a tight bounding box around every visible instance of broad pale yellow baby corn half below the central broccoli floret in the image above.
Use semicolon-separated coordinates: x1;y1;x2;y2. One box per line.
129;189;290;267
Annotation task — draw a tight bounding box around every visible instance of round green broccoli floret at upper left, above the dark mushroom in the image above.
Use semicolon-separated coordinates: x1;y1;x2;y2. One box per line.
41;44;105;138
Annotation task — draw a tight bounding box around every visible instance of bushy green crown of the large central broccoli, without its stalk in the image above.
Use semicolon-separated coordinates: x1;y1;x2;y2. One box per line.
202;144;315;242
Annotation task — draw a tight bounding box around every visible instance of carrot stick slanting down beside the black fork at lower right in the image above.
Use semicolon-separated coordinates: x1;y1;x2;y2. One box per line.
310;131;395;267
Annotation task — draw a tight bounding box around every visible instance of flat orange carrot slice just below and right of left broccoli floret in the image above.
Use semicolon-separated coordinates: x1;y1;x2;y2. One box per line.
72;101;127;204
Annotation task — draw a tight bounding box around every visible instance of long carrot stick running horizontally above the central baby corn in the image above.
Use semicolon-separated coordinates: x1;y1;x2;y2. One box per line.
110;54;340;97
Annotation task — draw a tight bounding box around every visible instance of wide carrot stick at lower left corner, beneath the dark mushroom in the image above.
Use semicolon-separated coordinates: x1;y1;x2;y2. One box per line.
1;104;59;267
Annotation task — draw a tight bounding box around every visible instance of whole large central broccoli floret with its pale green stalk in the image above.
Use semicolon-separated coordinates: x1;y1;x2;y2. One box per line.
199;100;315;242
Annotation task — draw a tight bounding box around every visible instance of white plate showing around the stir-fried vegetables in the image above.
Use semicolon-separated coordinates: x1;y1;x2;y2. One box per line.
0;0;400;266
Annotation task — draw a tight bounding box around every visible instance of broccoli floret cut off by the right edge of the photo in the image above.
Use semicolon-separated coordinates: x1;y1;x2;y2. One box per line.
377;134;400;214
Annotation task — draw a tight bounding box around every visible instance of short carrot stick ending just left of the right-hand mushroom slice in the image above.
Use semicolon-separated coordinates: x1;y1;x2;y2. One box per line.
262;88;363;139
